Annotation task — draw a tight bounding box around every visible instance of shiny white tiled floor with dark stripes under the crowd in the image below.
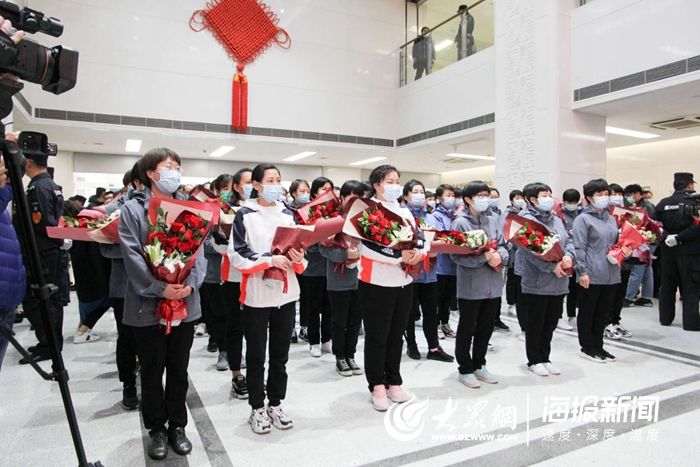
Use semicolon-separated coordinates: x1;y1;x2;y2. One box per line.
0;301;700;467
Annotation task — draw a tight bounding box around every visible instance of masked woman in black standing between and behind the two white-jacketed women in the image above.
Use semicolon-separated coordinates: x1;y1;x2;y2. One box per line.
302;177;333;358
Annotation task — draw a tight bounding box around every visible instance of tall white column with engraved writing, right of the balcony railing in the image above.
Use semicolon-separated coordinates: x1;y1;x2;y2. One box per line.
494;0;605;197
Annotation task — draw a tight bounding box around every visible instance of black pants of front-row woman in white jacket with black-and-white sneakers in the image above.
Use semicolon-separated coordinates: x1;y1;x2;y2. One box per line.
243;302;296;409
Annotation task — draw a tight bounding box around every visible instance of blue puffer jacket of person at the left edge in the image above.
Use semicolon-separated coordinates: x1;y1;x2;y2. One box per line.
0;184;26;309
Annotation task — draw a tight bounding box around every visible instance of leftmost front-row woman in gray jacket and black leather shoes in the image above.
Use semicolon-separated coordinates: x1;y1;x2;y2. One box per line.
119;148;206;459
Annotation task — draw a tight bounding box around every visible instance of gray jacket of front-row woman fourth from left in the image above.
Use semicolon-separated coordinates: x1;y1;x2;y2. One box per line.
451;209;508;300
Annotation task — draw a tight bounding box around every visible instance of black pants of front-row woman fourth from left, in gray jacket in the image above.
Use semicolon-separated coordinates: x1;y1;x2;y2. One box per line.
455;298;498;375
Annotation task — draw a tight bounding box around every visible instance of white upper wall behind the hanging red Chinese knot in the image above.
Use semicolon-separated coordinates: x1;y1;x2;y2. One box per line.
25;0;405;138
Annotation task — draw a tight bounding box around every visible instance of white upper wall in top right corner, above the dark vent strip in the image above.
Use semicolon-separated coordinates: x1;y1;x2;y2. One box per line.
571;0;700;89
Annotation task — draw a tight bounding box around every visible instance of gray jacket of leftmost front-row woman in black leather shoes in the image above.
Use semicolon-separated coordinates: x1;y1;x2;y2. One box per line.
119;188;207;327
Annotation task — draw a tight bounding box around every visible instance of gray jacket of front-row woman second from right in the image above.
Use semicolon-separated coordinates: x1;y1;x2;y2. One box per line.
520;207;575;296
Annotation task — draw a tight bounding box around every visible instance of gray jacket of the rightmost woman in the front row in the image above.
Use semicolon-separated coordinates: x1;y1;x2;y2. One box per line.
573;206;622;285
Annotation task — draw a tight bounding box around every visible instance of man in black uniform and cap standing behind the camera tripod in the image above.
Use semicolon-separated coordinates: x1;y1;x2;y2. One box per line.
13;144;63;364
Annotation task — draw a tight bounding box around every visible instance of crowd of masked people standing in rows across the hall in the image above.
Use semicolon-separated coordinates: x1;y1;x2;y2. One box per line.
0;144;700;459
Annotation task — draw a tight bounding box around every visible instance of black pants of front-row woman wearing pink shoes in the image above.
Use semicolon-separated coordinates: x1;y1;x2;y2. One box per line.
358;282;413;392
